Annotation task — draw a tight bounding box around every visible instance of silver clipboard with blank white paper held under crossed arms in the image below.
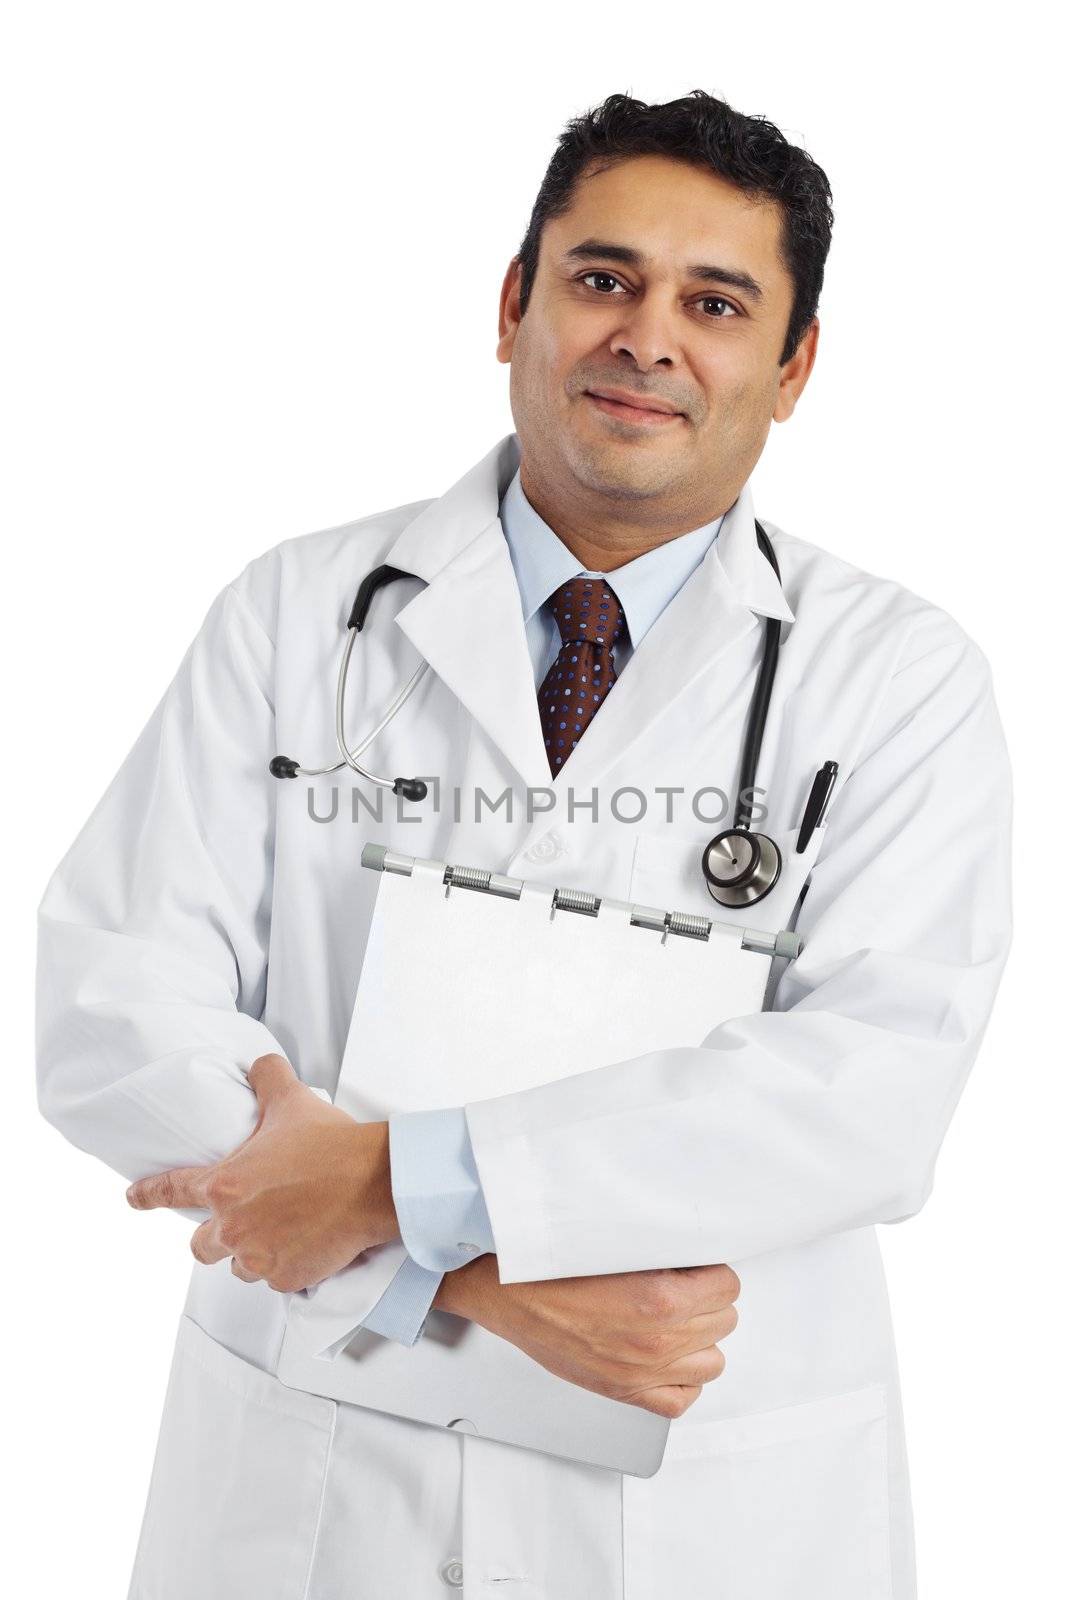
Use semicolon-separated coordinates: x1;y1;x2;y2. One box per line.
277;845;800;1477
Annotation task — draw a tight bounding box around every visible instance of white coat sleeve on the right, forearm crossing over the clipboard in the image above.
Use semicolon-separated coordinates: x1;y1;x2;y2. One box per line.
466;608;1011;1283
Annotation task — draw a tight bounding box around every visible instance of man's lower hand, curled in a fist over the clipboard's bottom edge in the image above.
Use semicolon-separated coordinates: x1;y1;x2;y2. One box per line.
434;1253;741;1418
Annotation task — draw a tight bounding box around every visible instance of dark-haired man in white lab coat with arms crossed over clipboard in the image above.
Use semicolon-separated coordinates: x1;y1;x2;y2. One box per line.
38;91;1009;1600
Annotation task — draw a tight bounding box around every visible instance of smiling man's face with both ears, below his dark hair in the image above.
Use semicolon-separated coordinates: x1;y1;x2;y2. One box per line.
498;155;817;547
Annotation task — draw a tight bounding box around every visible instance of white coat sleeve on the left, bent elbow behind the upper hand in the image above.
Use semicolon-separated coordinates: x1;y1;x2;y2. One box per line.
37;584;425;1342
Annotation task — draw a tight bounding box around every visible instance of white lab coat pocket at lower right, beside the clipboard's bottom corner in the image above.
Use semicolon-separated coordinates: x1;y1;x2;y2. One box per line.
622;1384;893;1600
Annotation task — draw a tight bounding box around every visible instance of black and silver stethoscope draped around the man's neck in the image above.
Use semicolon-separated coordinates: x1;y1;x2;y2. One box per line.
270;522;793;907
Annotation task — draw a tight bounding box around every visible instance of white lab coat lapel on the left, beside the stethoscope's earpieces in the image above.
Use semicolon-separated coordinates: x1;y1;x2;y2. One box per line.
386;434;550;787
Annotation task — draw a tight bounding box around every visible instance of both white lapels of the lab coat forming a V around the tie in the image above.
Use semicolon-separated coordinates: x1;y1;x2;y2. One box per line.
384;434;793;792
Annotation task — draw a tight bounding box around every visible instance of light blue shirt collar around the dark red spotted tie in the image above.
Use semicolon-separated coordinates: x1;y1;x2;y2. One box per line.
501;472;723;650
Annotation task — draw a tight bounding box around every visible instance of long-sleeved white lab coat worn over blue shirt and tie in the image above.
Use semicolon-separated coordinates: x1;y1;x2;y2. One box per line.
38;435;1009;1600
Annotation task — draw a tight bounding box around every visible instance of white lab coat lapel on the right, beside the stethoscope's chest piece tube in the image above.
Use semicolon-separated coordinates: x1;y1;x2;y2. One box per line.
547;483;793;792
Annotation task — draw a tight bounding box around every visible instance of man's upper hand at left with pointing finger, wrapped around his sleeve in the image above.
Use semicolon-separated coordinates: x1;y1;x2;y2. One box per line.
126;1054;400;1293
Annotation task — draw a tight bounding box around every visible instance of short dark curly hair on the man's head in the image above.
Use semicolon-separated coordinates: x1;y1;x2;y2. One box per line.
518;90;833;366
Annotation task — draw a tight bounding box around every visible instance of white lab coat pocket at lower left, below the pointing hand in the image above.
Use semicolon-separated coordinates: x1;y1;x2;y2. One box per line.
128;1315;338;1600
